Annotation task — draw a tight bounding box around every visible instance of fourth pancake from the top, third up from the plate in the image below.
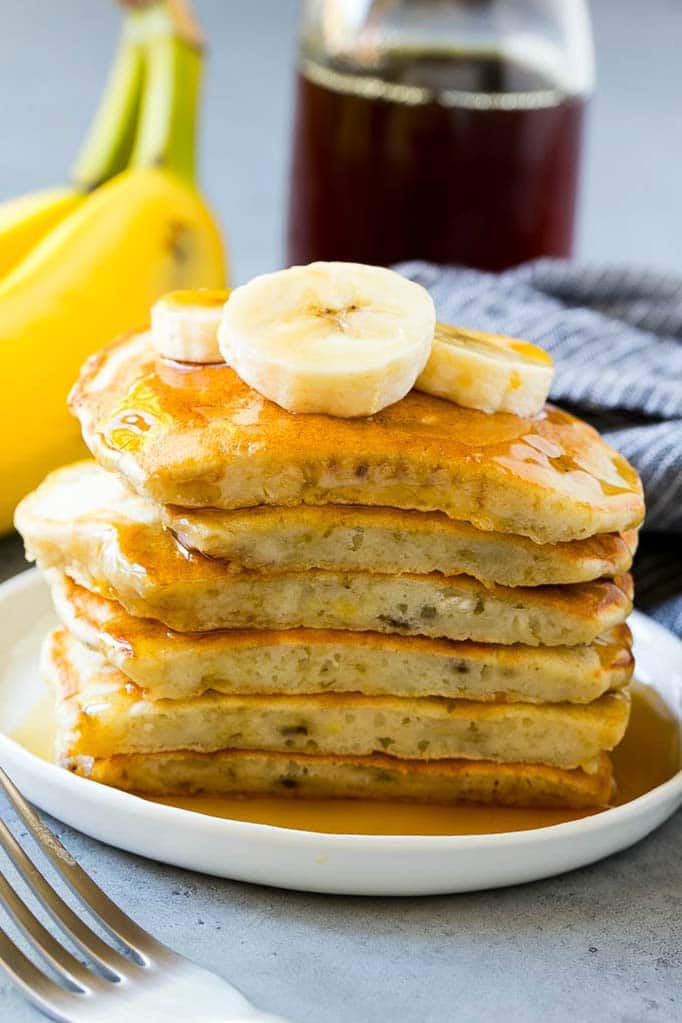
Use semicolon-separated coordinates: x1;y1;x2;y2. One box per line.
48;571;633;703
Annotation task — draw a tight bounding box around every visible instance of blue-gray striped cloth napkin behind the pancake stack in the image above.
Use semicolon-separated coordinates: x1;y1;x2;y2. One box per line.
396;260;682;636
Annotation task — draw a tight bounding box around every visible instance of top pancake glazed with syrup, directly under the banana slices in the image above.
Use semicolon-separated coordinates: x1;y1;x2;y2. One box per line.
70;335;644;543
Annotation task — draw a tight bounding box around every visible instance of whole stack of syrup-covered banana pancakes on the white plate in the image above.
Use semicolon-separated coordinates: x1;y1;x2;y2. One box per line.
16;335;643;808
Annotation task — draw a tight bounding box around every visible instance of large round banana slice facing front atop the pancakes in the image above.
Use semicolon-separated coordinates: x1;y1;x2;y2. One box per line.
218;263;436;417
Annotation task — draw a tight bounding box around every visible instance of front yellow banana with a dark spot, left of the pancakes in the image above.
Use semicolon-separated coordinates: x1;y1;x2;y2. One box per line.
0;163;224;531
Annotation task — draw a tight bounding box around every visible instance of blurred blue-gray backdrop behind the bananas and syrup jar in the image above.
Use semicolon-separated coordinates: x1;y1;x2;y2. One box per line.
0;0;682;283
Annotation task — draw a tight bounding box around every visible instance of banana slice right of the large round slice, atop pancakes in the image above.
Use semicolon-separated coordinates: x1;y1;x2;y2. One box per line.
415;323;554;415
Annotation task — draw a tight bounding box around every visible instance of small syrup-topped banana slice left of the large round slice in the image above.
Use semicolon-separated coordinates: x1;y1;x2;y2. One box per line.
151;287;229;363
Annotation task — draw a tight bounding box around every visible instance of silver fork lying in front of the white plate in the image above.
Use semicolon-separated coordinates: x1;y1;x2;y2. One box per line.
0;767;294;1023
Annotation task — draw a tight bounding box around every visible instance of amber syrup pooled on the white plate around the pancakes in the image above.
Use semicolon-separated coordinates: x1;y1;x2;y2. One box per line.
11;682;680;835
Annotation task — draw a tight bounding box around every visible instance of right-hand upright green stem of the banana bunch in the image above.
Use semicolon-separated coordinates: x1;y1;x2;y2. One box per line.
128;0;202;184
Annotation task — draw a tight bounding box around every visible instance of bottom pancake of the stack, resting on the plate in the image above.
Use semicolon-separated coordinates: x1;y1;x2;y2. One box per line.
69;750;612;810
